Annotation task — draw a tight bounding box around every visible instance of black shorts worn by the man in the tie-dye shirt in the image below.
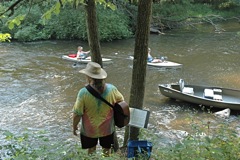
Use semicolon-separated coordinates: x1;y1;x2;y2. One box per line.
80;132;114;149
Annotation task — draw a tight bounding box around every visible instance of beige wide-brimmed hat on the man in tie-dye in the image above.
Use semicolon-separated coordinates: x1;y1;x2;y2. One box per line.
79;62;107;79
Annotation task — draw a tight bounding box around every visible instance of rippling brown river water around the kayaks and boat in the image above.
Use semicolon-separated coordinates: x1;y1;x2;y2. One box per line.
0;23;240;150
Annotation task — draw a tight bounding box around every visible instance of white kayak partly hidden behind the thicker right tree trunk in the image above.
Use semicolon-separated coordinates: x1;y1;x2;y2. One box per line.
130;56;182;68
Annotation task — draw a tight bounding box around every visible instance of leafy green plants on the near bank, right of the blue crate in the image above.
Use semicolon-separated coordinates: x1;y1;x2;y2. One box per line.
140;117;240;160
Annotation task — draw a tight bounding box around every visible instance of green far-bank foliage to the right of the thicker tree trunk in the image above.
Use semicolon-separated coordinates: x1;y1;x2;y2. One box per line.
152;0;240;29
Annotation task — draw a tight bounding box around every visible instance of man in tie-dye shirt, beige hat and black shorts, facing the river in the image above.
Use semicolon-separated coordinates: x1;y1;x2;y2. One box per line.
73;62;124;156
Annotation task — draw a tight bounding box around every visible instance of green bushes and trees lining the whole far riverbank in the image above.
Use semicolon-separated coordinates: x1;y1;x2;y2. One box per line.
0;0;240;42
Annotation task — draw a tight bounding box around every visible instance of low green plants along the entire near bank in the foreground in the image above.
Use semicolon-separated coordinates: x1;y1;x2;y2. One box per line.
0;116;240;160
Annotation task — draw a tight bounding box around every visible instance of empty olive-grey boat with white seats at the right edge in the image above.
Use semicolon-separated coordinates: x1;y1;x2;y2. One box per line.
158;79;240;110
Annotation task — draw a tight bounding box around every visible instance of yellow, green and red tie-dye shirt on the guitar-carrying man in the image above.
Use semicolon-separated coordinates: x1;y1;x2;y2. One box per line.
73;84;124;138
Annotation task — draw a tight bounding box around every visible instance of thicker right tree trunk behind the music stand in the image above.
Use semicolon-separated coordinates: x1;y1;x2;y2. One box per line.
129;0;152;140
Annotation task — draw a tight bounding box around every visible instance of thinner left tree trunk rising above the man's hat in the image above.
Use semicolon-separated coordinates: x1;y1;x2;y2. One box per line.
85;0;103;67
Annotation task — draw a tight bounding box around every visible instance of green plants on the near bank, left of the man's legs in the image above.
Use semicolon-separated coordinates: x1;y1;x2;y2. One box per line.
0;130;123;160
